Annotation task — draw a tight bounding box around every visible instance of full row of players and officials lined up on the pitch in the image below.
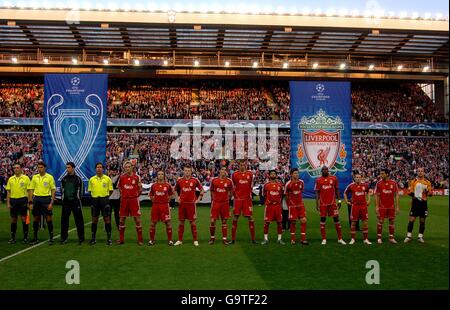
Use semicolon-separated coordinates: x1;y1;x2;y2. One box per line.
6;160;432;246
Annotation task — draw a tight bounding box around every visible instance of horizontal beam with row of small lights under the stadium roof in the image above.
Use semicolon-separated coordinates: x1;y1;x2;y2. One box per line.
0;53;449;74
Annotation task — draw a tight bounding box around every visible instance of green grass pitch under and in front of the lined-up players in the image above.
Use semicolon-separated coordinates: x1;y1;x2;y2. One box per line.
0;197;449;290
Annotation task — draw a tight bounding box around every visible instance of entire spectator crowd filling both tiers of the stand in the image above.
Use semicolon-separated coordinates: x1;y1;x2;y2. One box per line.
0;80;449;188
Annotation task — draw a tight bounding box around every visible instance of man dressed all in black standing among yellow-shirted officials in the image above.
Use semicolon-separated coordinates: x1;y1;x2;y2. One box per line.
61;162;84;244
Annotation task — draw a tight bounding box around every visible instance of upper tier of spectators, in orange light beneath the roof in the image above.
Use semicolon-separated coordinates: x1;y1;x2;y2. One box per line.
0;81;446;122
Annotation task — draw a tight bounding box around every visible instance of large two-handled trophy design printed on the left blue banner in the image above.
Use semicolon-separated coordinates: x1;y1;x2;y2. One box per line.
46;92;103;181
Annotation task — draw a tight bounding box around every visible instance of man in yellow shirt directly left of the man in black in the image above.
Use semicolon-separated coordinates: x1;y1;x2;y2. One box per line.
28;161;56;245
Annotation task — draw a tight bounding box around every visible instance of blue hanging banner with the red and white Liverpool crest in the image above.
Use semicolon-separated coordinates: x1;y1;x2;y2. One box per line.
290;81;352;198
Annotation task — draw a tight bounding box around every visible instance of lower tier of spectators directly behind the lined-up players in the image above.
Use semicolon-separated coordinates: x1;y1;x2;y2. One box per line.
0;133;449;188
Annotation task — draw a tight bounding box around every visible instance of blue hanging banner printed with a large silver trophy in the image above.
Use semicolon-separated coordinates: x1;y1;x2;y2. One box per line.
43;74;108;188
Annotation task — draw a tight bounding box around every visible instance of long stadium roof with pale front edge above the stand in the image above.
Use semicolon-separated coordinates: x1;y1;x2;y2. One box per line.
0;9;449;75
